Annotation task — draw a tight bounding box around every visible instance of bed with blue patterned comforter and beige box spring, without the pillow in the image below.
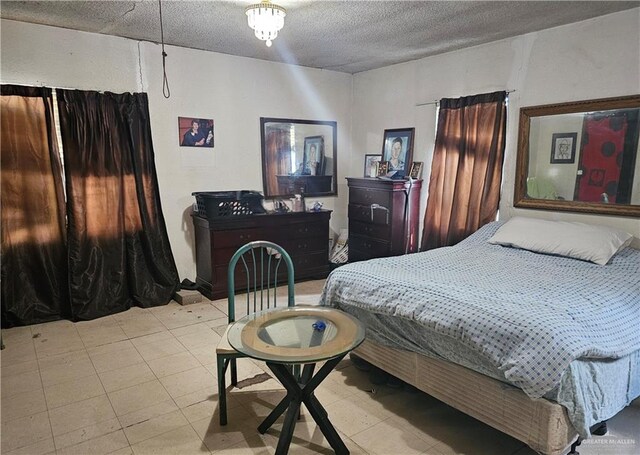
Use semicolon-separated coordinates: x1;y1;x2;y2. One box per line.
321;222;640;455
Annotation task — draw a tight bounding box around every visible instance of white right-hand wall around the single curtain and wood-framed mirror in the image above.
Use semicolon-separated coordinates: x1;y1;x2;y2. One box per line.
351;8;640;242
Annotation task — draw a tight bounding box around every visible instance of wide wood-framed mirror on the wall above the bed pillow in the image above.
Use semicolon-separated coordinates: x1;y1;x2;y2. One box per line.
514;95;640;216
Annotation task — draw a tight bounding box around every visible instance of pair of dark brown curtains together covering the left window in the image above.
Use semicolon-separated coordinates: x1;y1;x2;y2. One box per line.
0;85;179;327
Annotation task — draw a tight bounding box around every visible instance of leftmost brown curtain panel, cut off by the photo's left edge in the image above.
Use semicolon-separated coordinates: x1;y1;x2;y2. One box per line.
0;85;69;327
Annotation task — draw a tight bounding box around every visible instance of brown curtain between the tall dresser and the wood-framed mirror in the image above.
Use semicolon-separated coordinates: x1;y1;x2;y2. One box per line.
420;92;507;251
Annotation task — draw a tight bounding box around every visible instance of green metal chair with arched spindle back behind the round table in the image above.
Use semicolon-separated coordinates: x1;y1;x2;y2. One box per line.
216;241;295;425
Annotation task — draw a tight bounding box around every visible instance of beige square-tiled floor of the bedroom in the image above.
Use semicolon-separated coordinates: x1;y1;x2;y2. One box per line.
1;281;640;455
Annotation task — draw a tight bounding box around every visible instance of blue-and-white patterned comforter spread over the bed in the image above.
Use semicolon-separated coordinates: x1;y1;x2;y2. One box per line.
322;223;640;436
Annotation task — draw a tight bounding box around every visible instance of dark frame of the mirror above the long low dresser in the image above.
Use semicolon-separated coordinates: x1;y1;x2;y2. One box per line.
260;117;338;199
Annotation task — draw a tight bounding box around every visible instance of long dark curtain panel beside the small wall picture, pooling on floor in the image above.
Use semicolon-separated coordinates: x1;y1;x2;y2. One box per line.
58;90;179;320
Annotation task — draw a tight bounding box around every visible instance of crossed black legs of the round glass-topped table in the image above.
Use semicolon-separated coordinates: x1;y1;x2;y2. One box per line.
258;355;349;455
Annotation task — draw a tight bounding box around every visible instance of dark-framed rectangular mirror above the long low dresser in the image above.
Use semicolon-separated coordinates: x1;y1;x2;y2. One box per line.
260;117;338;197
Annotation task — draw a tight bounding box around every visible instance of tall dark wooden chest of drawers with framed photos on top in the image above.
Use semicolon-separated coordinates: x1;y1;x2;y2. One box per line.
347;177;422;262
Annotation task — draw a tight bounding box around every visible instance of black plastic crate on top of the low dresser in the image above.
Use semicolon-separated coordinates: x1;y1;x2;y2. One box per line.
191;190;265;219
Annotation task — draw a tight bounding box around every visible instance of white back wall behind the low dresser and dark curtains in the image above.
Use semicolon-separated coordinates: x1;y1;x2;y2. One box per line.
0;20;352;280
